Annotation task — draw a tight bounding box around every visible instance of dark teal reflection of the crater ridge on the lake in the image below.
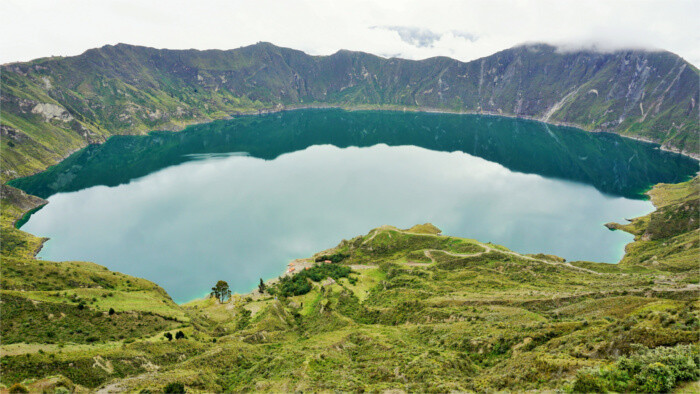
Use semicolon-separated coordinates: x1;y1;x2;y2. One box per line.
11;110;698;198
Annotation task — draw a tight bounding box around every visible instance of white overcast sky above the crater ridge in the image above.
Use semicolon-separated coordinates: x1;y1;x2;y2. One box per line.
0;0;700;66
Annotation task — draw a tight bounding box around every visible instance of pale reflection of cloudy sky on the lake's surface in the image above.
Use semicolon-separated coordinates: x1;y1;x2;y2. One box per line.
23;144;652;302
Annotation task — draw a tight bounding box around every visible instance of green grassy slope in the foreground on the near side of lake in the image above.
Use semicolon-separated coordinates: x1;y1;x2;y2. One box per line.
0;179;700;392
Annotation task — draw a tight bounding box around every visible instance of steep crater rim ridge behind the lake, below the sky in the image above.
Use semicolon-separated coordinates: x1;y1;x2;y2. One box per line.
0;43;700;181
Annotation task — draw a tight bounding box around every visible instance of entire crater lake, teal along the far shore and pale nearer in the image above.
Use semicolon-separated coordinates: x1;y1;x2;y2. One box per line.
12;110;698;302
